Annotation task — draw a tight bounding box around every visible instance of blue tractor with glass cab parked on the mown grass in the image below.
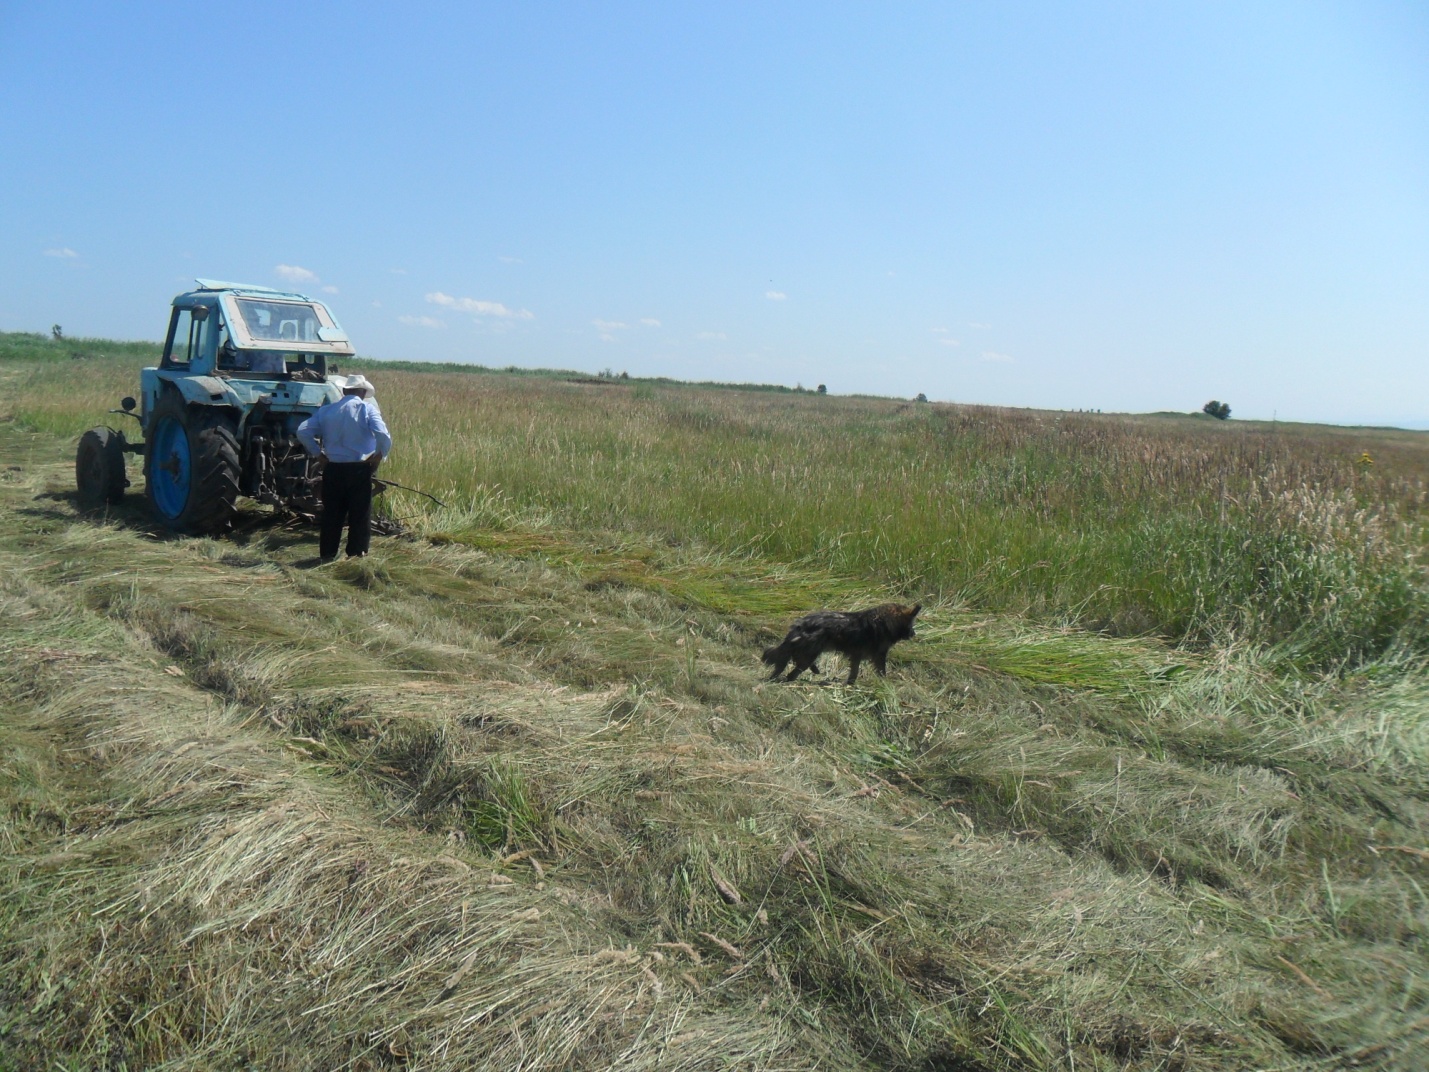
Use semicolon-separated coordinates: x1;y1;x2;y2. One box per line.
74;279;365;535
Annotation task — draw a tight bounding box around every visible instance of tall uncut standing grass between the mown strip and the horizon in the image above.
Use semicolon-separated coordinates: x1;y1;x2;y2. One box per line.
7;336;1429;669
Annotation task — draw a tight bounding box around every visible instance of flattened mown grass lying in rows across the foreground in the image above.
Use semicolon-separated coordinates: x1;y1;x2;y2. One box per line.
0;414;1429;1071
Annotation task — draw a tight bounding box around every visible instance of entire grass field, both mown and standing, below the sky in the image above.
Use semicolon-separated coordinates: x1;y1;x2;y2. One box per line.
0;336;1429;1072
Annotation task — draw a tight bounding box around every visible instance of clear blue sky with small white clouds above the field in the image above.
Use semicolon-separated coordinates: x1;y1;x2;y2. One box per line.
0;0;1429;426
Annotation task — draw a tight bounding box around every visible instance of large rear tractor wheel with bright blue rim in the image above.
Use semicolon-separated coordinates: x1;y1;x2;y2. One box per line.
144;394;239;536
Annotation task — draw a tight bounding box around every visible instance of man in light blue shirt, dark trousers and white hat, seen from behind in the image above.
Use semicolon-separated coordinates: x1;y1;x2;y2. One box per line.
297;376;392;562
